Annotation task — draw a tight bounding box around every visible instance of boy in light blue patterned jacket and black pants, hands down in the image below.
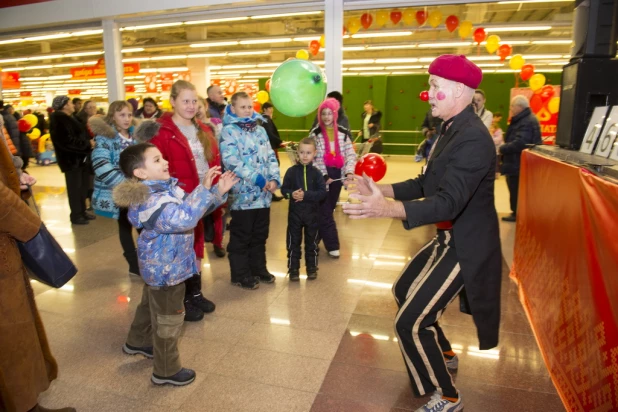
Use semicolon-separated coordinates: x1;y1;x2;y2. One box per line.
219;92;281;289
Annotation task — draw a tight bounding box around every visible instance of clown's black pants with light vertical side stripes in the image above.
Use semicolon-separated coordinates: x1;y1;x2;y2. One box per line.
393;230;463;397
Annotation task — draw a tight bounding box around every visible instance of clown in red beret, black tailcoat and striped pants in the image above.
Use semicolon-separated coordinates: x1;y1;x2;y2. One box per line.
343;55;502;412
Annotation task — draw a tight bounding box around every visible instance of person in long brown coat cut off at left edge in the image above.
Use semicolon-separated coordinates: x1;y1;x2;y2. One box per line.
0;124;75;412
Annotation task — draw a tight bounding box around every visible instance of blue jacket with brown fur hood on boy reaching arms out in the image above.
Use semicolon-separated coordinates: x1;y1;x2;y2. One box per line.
114;178;227;286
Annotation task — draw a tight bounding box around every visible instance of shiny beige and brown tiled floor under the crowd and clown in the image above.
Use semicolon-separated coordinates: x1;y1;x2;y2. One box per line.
25;156;564;412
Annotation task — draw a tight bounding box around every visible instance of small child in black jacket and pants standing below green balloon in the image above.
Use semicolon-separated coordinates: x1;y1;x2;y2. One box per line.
281;137;327;281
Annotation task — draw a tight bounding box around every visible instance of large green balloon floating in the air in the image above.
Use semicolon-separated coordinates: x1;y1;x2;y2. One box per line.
270;59;326;117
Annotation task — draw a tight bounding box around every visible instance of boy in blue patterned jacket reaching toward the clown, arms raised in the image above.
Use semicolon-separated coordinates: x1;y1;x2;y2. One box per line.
113;143;238;386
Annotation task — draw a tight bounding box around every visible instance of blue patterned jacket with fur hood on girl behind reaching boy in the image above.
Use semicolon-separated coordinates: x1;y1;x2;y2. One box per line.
88;116;136;219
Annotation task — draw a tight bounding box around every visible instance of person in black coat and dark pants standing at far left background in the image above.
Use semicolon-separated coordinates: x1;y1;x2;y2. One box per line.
49;96;95;225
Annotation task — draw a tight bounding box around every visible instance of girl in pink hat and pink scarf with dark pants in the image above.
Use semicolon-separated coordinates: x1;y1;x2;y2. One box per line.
309;98;356;259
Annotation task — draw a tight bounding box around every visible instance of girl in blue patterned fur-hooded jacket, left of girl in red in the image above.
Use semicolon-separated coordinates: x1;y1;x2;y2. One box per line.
88;100;139;275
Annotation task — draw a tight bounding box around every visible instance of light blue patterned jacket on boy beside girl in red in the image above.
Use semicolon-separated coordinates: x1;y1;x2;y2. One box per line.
219;105;281;210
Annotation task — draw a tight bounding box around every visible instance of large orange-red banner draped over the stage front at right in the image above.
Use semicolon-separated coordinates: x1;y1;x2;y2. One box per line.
511;151;618;411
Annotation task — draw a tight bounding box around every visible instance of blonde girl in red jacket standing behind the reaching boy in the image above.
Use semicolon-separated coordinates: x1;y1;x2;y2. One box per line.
138;80;221;321
